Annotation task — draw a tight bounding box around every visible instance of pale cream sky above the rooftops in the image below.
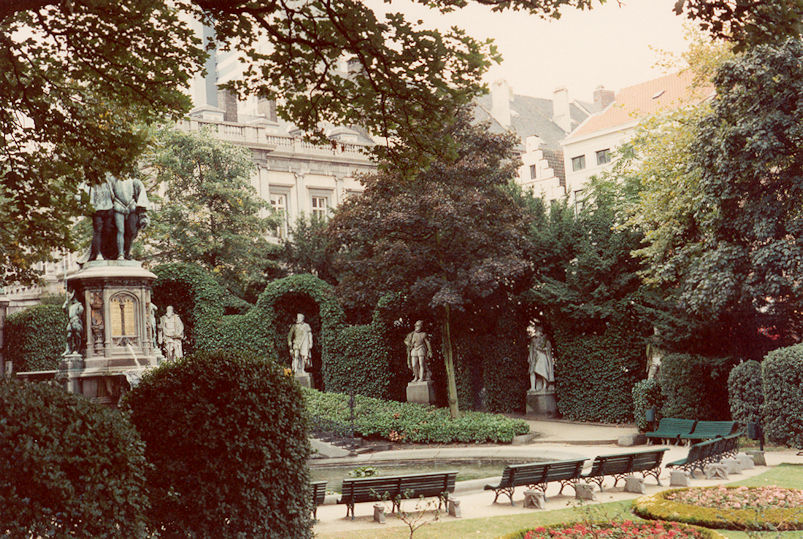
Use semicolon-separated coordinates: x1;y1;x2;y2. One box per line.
364;0;687;101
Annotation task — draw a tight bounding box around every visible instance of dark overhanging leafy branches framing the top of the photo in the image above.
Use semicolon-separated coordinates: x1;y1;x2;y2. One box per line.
0;0;801;282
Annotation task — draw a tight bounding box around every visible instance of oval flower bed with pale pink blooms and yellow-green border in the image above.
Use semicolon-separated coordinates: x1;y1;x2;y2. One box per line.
633;486;803;530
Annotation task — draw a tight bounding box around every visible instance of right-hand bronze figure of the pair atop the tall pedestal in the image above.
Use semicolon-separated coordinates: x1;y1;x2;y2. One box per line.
110;177;150;260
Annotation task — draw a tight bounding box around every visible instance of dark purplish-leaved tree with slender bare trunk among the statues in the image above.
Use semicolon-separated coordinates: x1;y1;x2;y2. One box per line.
330;113;529;417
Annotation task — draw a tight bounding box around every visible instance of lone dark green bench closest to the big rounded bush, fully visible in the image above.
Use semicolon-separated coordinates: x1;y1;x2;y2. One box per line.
337;471;457;520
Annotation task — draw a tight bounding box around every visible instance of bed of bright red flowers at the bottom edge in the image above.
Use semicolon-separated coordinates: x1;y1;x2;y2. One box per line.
500;520;724;539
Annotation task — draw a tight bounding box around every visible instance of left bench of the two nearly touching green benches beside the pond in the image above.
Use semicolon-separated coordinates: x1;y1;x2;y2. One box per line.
484;458;588;505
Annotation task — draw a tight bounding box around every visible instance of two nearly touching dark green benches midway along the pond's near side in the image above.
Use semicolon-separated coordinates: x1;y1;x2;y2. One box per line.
485;448;667;505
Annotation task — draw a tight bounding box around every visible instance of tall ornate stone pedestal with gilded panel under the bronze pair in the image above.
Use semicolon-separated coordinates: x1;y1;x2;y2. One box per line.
57;260;162;404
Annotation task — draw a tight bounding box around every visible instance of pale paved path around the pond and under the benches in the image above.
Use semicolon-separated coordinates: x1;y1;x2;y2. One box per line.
315;421;803;537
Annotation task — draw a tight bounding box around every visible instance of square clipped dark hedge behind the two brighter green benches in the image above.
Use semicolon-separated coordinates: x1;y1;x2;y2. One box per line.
658;354;732;420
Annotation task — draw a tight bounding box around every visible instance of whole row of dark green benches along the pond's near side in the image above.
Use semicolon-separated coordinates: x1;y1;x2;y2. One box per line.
312;434;739;520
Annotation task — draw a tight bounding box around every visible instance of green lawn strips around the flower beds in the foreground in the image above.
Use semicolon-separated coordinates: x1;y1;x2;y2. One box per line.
316;464;803;539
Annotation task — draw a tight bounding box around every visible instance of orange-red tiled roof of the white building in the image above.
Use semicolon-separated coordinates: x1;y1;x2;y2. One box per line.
566;69;714;140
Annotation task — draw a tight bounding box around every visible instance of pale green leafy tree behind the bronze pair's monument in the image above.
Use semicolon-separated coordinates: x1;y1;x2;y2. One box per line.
144;129;278;299
